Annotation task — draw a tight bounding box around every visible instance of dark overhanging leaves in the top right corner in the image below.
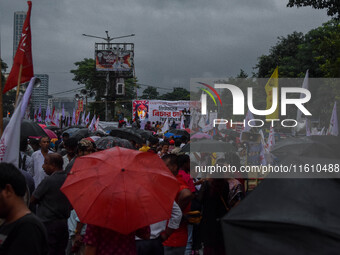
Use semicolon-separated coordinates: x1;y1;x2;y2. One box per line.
287;0;340;19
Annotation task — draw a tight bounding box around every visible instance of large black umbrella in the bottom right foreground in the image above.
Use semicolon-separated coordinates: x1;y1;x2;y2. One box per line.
222;179;340;255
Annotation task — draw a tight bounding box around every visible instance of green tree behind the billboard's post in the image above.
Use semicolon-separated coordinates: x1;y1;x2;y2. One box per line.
70;58;138;119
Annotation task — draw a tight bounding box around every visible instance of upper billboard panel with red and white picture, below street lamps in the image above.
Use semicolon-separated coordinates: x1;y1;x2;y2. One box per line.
95;43;134;78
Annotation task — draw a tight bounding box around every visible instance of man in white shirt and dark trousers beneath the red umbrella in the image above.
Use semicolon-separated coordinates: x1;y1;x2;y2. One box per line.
136;202;182;255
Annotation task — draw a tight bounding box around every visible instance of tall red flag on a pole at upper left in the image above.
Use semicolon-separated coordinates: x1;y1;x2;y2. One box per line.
3;1;34;93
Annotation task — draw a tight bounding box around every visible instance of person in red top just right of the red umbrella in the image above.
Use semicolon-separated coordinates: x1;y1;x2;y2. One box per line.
162;154;193;255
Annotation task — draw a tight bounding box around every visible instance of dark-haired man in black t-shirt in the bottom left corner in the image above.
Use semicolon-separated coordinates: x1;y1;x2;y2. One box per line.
0;163;48;255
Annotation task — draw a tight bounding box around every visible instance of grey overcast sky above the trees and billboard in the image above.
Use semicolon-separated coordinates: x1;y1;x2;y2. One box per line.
0;0;329;97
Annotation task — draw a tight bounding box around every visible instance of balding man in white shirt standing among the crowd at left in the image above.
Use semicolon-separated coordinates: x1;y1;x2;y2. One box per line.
29;136;52;187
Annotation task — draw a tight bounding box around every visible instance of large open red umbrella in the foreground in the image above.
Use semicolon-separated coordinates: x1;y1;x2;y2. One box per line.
61;147;179;234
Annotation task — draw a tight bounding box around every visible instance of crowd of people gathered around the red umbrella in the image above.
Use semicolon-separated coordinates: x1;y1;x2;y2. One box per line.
0;118;245;255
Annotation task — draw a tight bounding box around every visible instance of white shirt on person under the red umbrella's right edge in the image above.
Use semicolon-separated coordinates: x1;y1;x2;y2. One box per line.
136;202;182;240
